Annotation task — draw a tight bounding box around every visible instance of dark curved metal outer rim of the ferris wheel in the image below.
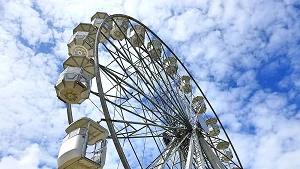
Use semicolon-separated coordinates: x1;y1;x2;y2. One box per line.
94;14;243;168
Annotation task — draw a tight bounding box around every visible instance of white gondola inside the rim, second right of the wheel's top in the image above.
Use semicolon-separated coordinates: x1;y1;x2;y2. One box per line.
130;25;145;47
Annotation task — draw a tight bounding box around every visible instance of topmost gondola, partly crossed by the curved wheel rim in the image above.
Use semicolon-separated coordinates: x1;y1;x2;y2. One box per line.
91;12;112;43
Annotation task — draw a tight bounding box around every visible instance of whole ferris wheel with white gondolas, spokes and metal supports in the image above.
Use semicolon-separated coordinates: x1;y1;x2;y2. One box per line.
55;12;243;169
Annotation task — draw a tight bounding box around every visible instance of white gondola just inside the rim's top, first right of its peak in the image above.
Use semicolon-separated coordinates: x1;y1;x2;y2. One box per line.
110;17;129;40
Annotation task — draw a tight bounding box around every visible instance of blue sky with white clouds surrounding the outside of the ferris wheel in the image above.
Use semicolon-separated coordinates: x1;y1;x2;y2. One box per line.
0;0;300;169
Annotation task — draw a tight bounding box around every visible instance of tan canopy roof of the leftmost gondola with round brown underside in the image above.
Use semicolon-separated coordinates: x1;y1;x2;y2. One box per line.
63;56;95;79
